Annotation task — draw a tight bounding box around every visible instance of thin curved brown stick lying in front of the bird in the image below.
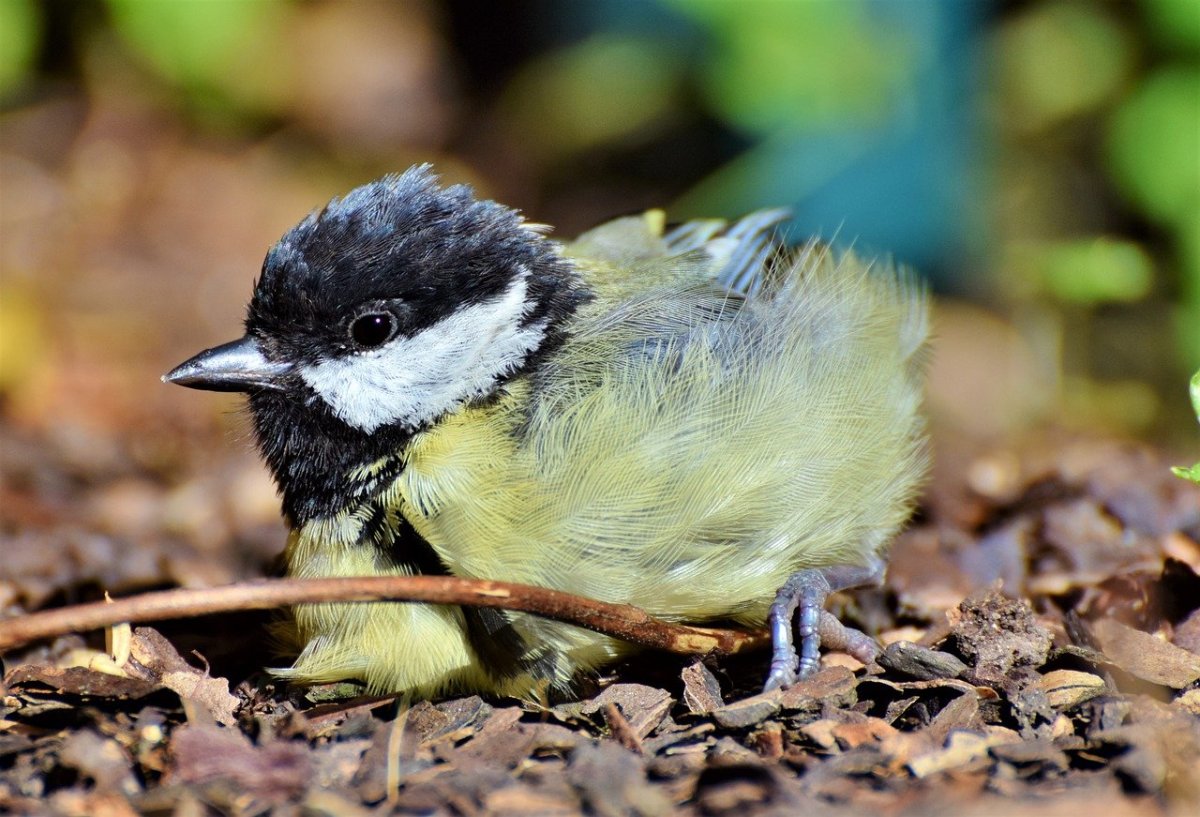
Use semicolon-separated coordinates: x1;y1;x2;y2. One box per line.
0;576;768;655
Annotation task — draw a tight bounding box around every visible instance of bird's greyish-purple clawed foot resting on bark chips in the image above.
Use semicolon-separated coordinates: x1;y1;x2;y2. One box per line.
763;561;884;692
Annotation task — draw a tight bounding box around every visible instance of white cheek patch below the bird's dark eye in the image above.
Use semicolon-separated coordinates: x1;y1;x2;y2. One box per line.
300;274;546;433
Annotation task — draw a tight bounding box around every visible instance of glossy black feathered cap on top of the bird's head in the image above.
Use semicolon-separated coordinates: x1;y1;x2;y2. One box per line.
246;164;586;361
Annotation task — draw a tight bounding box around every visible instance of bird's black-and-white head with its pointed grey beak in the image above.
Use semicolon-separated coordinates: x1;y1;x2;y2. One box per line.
163;166;587;518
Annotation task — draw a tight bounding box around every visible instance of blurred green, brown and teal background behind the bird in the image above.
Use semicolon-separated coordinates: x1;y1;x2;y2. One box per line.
0;0;1200;445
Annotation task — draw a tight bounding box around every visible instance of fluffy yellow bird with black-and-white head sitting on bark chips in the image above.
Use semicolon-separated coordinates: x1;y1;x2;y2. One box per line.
163;164;929;699
